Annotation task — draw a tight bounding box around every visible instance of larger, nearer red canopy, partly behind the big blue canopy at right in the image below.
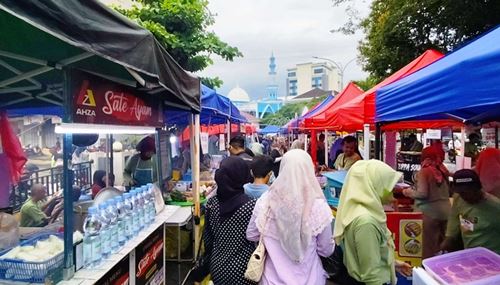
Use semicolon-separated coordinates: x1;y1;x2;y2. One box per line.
318;49;461;131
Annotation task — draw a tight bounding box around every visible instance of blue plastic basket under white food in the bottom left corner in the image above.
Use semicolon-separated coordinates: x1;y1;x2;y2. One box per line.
0;233;64;283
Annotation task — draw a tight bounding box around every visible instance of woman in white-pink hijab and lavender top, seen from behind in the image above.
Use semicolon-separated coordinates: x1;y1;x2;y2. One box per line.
247;149;334;285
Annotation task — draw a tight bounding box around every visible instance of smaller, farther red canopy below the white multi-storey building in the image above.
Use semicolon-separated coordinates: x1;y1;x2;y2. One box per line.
301;82;363;129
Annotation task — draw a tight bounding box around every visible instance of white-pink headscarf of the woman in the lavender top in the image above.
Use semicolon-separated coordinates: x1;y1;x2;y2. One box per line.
256;149;332;262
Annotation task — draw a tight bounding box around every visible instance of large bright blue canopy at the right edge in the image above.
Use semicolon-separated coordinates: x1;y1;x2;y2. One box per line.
376;26;500;123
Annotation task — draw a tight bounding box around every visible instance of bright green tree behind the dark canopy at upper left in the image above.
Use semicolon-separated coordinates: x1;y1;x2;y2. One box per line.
114;0;242;88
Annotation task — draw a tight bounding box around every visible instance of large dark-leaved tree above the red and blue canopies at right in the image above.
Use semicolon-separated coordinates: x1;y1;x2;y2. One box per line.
332;0;500;81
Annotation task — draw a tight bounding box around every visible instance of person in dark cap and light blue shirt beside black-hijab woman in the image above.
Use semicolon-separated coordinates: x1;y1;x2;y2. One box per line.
243;155;274;199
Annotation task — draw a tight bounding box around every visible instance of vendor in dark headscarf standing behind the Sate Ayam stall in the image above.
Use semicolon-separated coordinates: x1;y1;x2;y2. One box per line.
123;136;158;186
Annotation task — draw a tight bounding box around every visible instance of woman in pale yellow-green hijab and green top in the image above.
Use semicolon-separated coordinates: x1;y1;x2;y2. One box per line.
333;160;411;285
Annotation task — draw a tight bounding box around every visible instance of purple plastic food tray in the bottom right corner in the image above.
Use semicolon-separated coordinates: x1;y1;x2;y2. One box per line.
423;247;500;285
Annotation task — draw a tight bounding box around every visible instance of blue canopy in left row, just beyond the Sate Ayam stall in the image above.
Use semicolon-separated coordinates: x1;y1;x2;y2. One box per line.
165;85;247;126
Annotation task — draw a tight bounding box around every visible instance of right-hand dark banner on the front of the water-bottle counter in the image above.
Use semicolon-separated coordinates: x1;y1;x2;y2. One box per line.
135;224;165;285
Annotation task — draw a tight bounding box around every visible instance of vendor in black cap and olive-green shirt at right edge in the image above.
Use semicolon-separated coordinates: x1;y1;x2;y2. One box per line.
441;169;500;254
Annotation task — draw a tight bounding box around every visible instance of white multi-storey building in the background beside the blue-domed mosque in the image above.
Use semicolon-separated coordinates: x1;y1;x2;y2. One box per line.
286;62;340;97
